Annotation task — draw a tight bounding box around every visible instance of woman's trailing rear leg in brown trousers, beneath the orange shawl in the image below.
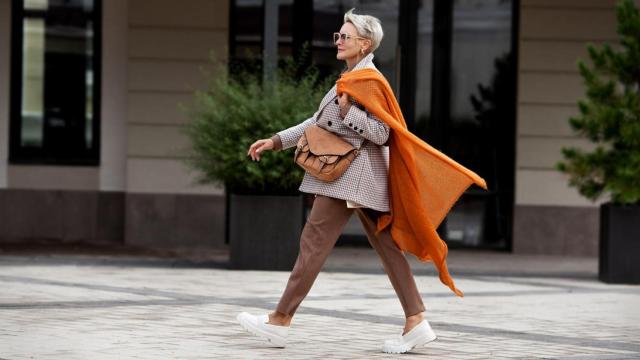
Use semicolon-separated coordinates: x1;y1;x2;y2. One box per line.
356;208;425;330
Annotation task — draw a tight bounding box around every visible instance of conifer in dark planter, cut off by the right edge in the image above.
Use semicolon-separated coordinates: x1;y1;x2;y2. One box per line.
557;0;640;284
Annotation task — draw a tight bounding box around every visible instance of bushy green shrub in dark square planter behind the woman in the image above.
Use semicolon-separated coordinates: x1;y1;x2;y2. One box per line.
183;54;326;270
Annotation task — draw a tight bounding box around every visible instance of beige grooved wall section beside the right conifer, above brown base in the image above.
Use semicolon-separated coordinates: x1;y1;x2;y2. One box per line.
516;0;616;206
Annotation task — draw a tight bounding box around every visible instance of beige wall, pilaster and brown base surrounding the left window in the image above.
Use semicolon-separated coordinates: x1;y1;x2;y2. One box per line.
0;0;127;244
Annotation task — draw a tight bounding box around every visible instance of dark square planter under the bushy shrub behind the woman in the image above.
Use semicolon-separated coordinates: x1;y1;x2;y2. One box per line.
228;194;304;270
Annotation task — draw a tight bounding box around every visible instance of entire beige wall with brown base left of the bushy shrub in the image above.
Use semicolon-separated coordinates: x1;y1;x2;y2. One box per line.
0;0;229;247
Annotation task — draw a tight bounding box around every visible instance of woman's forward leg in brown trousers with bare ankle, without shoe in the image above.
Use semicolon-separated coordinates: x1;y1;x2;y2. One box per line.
269;195;353;326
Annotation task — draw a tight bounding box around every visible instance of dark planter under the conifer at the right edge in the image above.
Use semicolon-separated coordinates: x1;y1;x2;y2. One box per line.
598;203;640;284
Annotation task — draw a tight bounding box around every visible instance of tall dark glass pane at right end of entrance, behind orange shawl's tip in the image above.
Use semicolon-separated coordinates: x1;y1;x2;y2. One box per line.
445;0;516;247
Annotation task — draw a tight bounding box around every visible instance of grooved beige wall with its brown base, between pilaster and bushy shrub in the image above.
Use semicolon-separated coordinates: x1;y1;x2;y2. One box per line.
125;0;229;247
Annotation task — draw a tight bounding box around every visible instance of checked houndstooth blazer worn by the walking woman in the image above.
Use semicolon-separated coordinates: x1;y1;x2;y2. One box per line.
272;54;389;212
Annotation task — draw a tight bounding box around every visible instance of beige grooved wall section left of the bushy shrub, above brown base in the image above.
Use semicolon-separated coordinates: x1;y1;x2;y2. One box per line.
126;0;229;194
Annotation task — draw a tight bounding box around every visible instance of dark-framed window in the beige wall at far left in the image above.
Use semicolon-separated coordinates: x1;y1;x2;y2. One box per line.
9;0;100;165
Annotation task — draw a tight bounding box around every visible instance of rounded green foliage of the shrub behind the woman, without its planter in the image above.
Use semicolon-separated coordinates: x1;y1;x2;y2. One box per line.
183;53;328;195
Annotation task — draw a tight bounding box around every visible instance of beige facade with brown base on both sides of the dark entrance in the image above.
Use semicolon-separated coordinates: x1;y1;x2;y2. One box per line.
0;0;632;256
